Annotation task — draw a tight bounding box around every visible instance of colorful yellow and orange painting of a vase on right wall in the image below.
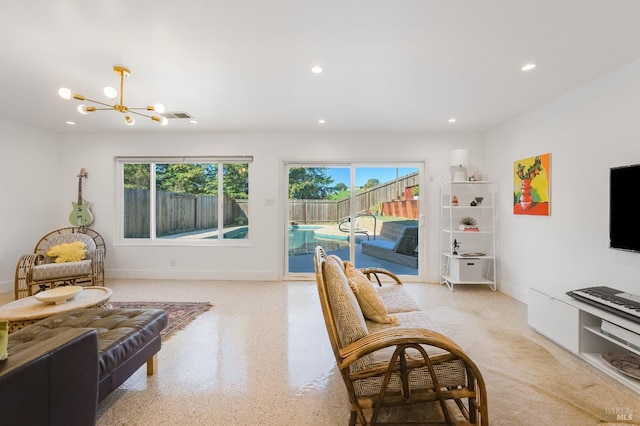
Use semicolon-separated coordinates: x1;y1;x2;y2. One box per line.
513;153;551;216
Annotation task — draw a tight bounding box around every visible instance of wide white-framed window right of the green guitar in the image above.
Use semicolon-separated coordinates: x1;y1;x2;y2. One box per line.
116;157;252;245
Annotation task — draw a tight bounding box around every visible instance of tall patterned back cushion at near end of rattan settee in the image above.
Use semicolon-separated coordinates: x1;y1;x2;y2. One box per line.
323;256;368;347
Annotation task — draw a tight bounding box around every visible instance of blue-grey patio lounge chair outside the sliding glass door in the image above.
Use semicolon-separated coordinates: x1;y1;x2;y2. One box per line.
361;226;418;268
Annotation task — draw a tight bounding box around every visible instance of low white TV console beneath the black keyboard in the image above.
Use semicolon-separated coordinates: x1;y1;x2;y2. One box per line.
528;288;640;394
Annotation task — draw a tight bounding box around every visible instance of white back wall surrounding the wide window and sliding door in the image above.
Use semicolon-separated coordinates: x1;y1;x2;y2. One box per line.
0;130;483;292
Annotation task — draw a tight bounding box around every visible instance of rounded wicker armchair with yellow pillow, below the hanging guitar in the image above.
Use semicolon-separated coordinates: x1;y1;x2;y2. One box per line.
15;227;105;300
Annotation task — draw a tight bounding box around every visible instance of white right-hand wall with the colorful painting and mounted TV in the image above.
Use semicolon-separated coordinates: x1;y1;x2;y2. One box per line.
485;57;640;301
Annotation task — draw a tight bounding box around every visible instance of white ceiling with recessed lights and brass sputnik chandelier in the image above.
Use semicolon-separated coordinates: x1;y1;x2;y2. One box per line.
0;0;640;133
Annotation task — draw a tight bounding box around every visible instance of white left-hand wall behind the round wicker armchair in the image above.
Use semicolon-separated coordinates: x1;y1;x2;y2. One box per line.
0;119;62;292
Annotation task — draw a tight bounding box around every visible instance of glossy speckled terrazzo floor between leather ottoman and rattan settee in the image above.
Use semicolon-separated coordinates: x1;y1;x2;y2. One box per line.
97;280;348;426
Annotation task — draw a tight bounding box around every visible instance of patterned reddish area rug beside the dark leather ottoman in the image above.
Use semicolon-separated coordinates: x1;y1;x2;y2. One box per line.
111;301;213;343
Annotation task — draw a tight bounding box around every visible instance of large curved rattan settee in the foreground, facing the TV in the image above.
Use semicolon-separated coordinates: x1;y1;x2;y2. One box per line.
315;247;489;425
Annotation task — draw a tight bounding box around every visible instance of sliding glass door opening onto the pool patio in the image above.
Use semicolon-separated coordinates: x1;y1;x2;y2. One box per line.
285;163;423;276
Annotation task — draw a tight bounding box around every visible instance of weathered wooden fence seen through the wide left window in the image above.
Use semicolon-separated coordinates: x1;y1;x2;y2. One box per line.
124;189;249;238
